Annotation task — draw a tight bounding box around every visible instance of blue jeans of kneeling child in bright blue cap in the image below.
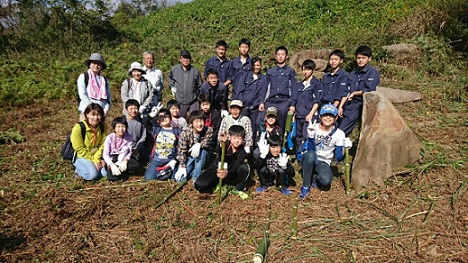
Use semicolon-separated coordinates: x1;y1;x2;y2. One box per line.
302;151;333;187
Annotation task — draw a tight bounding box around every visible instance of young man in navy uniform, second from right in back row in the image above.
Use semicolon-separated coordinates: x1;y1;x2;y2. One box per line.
322;49;348;108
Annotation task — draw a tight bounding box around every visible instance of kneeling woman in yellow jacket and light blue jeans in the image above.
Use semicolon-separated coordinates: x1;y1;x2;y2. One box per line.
70;103;107;181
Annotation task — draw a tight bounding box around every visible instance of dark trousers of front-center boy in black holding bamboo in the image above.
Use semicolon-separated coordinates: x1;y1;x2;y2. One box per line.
194;163;250;193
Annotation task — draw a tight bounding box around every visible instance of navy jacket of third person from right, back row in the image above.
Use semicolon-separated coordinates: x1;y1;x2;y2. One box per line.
295;78;323;118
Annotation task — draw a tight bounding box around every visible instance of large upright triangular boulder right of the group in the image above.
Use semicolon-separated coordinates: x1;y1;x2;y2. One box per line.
351;92;422;188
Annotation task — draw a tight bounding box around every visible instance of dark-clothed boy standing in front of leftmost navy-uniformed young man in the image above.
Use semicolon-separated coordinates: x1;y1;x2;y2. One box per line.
200;69;228;117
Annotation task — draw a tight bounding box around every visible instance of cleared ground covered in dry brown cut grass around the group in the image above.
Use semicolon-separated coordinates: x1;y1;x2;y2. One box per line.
0;94;468;262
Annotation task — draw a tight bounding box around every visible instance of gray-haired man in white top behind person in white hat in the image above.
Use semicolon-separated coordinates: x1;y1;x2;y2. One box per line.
143;51;164;106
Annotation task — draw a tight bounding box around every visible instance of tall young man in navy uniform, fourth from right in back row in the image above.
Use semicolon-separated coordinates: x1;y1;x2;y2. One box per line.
257;46;297;135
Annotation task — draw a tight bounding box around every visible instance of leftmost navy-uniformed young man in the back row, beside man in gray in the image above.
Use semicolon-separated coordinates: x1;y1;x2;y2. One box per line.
204;40;231;87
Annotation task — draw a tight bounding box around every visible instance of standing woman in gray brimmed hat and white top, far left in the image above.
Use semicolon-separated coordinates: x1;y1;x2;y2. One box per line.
76;53;111;121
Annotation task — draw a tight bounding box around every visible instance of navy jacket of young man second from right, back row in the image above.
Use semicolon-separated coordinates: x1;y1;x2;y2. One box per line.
322;68;349;103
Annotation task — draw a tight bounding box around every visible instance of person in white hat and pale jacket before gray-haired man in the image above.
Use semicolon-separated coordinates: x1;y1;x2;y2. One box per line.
120;62;156;115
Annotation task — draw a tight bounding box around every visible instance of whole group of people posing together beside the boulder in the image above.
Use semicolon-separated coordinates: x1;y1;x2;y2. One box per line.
71;39;380;198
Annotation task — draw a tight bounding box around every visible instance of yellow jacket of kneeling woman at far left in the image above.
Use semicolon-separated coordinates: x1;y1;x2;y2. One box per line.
70;121;106;163
